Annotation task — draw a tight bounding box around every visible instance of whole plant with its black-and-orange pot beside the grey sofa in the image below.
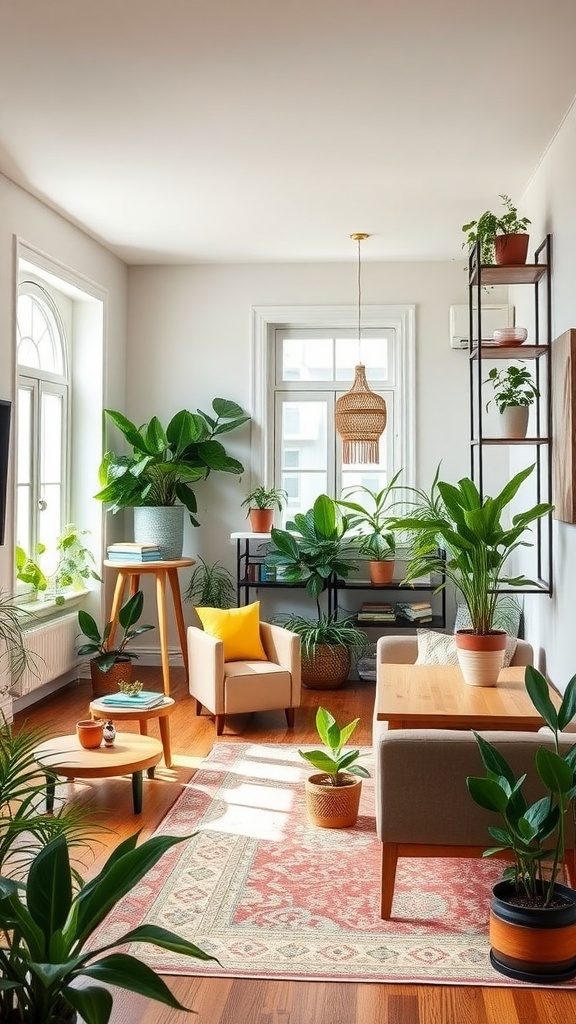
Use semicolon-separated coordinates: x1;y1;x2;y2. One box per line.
466;666;576;983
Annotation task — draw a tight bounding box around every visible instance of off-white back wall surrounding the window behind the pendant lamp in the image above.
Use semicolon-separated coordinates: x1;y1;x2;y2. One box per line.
127;261;469;636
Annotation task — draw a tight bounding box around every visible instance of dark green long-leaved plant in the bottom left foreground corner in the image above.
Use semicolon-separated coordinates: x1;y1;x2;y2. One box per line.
0;833;214;1024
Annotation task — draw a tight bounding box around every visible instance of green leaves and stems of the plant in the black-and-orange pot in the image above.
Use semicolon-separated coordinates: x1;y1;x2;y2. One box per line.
466;666;576;906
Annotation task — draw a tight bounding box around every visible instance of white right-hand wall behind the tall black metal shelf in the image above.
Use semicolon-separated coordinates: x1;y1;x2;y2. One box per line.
511;99;576;690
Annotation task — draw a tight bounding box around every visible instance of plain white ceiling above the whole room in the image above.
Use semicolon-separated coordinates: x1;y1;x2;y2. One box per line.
0;0;576;263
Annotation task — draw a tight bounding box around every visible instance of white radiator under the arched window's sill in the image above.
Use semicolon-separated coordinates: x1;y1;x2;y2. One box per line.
16;613;79;695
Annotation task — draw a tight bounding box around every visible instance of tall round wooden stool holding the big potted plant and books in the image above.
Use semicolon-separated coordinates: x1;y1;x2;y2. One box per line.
104;558;195;696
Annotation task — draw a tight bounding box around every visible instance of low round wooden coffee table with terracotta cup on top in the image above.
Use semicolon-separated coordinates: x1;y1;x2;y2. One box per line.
34;732;162;814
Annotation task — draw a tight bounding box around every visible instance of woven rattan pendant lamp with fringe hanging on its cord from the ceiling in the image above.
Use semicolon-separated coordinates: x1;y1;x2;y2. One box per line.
334;231;387;465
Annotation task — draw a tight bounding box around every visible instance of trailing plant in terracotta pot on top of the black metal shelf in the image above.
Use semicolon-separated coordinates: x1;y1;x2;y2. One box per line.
462;193;530;266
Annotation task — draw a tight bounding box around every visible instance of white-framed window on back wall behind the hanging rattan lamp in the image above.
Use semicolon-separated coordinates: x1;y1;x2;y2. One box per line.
249;307;414;520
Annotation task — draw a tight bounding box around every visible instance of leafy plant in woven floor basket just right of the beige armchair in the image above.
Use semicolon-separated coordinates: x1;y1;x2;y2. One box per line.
265;495;358;689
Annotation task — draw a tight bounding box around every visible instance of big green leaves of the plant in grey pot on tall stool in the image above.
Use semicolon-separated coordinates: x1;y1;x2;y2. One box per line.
94;398;250;526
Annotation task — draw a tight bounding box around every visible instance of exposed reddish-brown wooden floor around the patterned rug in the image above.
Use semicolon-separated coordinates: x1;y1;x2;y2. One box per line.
15;668;576;1024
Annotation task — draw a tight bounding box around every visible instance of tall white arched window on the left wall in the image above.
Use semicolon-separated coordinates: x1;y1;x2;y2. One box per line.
16;280;70;571
